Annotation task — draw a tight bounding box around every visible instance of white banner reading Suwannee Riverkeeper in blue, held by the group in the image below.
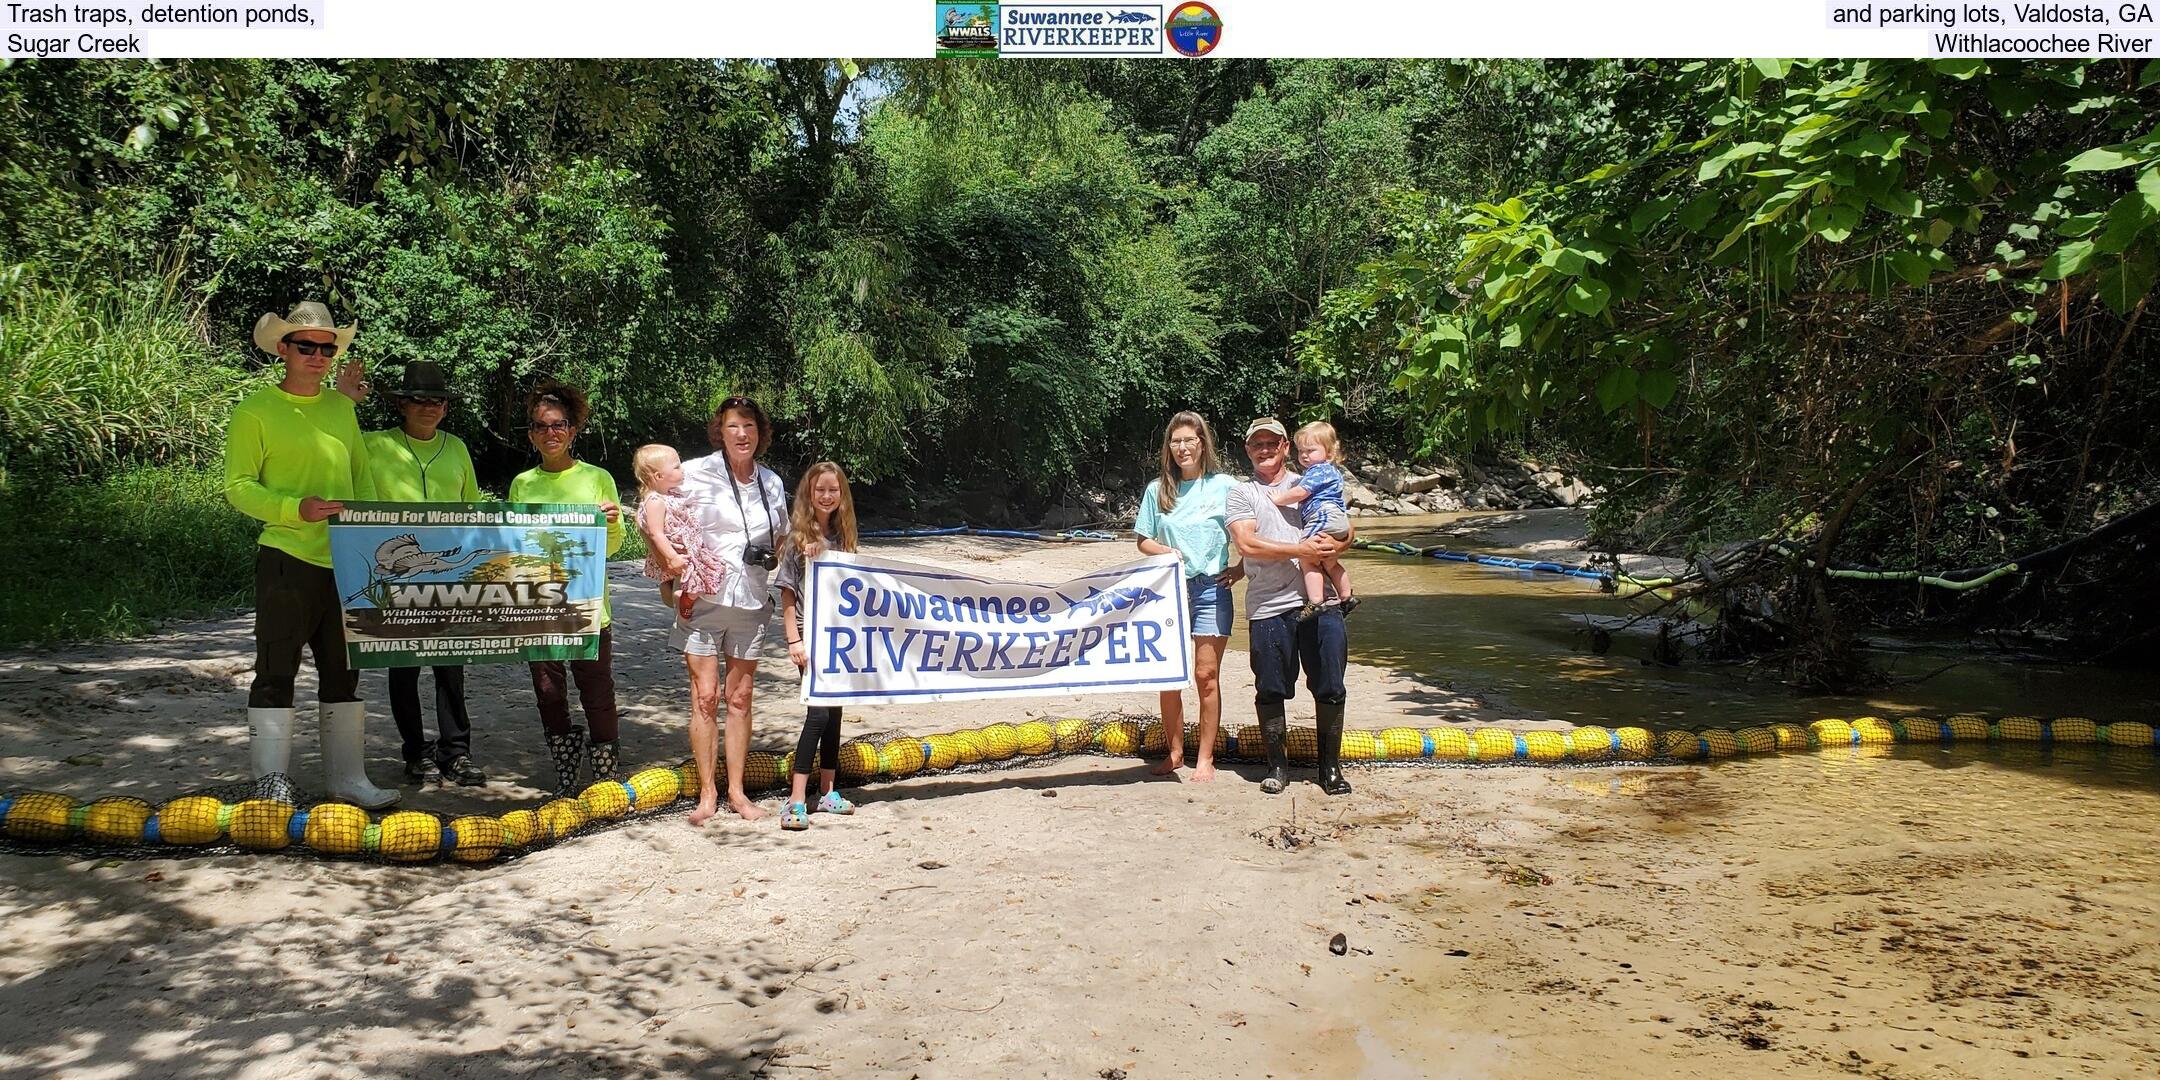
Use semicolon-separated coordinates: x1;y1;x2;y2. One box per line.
801;551;1192;704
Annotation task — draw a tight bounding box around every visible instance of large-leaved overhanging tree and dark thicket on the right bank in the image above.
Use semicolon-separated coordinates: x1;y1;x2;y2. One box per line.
1302;60;2160;566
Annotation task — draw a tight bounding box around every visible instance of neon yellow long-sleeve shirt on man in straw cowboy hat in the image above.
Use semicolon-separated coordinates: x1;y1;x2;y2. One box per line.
225;387;376;566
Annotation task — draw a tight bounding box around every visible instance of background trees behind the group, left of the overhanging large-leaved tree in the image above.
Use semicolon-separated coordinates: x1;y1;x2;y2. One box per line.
0;60;1330;492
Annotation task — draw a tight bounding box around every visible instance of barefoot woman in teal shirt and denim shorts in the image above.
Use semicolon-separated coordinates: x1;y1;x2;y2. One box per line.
1132;413;1244;782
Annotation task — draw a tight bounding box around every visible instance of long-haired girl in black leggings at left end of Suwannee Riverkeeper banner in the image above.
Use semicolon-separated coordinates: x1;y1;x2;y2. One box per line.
773;462;855;829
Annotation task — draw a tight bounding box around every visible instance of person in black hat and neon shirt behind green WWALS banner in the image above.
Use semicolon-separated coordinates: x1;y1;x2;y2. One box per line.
363;361;488;786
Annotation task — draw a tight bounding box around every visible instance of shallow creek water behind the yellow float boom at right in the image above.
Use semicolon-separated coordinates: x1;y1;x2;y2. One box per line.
1231;514;2160;726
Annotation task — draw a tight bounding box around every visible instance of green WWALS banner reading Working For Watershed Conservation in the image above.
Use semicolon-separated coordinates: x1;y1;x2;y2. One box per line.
330;503;607;667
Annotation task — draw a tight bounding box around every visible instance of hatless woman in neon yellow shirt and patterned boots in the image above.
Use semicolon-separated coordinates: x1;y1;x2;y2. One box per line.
510;382;622;795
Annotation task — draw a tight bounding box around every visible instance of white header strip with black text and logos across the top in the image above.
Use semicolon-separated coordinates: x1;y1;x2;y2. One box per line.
0;0;2160;63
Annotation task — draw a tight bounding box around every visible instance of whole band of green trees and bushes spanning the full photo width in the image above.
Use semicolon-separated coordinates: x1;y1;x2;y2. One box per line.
0;60;2160;652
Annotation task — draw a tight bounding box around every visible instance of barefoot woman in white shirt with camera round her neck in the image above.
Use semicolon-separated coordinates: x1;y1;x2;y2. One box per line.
667;397;788;825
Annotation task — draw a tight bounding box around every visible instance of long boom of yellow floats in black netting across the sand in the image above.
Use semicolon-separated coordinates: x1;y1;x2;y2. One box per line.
0;713;2154;864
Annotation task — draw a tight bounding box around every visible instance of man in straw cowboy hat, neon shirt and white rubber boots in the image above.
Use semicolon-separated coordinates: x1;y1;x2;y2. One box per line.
225;300;397;810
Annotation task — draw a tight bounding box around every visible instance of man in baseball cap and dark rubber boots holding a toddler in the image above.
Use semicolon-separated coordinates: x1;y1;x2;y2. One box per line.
1227;417;1350;795
